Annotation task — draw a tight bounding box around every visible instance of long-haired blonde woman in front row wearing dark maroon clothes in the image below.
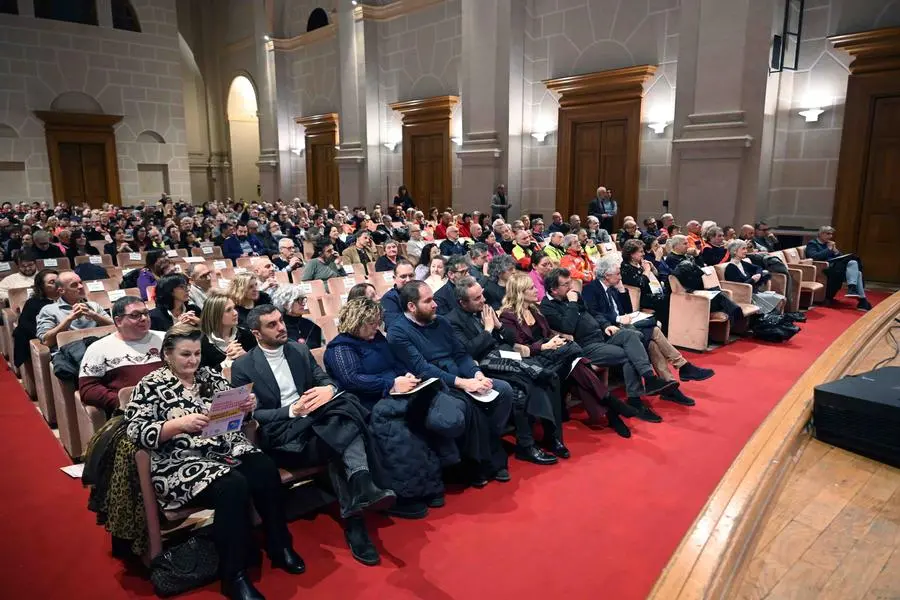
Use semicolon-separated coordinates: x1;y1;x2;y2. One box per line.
499;273;634;438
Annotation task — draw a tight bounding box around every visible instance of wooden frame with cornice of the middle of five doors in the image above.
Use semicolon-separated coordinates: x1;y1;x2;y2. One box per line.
389;96;459;211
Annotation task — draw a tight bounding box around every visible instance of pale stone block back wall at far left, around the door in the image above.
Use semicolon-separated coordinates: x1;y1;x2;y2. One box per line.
0;0;191;204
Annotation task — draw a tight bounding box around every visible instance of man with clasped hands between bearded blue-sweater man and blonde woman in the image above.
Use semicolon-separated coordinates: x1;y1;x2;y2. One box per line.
446;277;570;465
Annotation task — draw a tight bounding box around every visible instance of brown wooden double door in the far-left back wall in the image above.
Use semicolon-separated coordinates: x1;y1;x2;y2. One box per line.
59;142;109;208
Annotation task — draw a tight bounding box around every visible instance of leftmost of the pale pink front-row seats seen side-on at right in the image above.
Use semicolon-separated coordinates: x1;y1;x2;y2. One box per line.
667;275;731;352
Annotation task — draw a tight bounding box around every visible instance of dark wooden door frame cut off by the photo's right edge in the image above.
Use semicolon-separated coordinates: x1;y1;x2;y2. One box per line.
829;27;900;250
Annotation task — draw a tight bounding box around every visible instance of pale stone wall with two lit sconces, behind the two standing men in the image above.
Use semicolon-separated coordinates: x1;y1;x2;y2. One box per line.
522;0;679;218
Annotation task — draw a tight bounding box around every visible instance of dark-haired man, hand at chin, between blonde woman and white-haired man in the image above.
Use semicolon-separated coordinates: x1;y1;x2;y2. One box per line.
541;269;678;423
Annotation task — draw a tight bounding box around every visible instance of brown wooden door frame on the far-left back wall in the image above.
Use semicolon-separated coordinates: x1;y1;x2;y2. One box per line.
34;110;122;206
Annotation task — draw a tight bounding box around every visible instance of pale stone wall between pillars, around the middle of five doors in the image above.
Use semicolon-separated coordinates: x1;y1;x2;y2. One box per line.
370;0;462;206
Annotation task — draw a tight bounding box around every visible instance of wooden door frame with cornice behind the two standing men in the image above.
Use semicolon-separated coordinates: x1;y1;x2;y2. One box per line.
544;65;656;225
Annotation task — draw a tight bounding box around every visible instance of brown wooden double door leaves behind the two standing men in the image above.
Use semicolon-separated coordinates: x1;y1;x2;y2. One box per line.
569;119;628;221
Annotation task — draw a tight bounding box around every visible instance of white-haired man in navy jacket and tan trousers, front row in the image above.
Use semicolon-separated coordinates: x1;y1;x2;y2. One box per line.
582;256;715;406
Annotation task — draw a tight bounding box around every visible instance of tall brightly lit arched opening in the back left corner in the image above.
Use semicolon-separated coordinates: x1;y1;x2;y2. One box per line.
225;73;260;201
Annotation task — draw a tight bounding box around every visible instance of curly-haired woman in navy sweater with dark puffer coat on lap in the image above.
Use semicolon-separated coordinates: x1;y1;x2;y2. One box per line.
325;297;465;519
